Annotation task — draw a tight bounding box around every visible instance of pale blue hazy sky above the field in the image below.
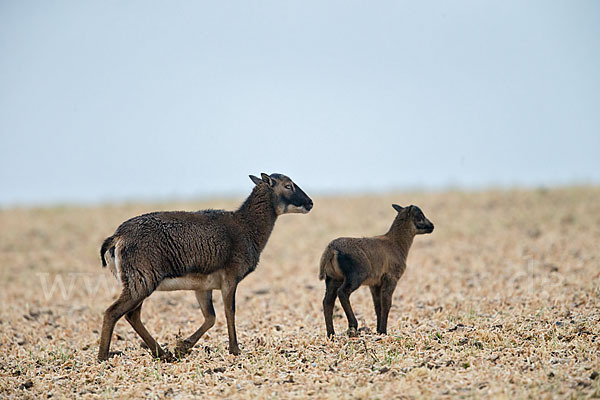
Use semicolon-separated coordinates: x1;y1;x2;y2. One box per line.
0;0;600;206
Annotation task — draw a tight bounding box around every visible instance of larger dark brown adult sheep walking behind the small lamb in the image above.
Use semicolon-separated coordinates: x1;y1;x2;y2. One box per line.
98;173;313;361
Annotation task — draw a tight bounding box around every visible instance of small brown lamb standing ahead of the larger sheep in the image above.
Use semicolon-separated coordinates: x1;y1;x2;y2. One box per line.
319;204;433;338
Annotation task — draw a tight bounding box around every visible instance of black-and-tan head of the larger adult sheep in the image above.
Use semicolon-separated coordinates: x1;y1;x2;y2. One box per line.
250;173;313;215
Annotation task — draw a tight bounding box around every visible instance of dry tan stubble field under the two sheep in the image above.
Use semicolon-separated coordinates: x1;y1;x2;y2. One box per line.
0;187;600;399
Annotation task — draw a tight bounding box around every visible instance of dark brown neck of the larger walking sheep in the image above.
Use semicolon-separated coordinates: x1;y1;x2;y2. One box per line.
236;184;277;253
